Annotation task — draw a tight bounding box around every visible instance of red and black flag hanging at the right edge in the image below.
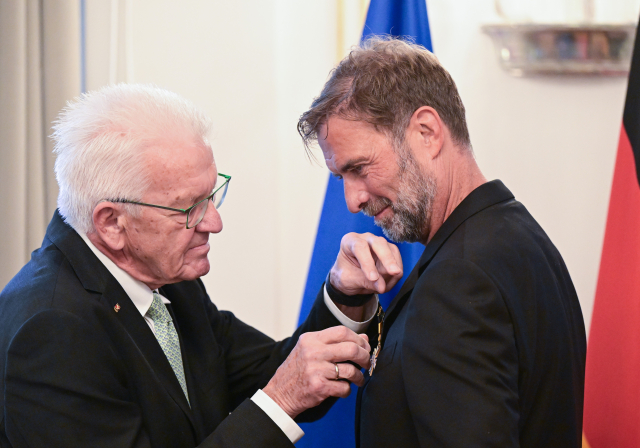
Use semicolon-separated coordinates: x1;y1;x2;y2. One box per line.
584;19;640;448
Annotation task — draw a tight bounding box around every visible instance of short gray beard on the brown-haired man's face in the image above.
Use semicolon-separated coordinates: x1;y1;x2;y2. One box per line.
362;152;436;243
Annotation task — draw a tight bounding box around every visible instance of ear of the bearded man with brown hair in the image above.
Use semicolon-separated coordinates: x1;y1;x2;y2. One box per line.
407;106;445;159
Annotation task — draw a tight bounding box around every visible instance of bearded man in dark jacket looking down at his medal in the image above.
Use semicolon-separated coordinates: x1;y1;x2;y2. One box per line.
298;38;586;448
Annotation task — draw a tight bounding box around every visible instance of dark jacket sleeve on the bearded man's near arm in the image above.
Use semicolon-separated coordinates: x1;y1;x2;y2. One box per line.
402;260;519;448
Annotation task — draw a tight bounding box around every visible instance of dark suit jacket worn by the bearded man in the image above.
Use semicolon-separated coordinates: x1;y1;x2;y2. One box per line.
356;181;586;448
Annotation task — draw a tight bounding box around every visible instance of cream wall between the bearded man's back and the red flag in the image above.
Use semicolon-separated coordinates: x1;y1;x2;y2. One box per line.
428;0;638;336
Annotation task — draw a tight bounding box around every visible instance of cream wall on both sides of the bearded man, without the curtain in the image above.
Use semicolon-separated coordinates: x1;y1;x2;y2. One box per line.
77;0;637;337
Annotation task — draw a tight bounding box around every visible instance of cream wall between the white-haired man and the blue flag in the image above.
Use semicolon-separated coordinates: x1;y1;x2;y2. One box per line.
87;0;336;337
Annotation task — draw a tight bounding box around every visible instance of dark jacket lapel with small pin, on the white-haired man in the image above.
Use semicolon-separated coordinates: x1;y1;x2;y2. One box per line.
46;210;195;430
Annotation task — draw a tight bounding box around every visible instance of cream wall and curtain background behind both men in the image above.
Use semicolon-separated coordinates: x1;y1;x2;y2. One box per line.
0;0;640;338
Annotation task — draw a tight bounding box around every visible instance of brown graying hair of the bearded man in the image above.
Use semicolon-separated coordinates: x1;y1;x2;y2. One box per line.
298;36;471;151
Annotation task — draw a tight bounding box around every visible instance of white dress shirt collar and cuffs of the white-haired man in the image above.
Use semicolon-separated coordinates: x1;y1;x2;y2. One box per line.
80;234;378;443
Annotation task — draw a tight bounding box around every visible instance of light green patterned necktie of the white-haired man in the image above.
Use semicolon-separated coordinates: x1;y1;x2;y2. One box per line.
147;292;191;404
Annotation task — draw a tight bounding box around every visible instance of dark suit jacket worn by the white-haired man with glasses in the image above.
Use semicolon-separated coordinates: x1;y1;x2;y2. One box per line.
0;213;338;448
